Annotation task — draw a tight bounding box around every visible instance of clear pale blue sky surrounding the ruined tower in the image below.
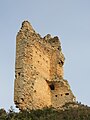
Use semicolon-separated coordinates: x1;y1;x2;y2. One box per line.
0;0;90;110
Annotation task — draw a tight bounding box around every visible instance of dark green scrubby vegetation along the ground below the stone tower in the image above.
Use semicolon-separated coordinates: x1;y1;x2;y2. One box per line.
0;104;90;120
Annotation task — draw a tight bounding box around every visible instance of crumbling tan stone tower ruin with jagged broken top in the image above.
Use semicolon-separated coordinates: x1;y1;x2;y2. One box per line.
14;21;75;110
